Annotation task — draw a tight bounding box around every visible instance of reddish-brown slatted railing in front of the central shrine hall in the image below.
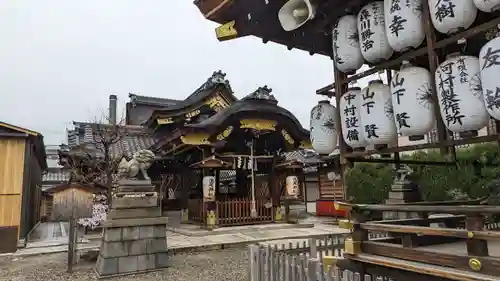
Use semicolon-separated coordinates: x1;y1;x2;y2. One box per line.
217;198;273;226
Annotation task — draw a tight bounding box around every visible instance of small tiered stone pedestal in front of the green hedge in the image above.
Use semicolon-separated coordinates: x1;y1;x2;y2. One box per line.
383;167;422;220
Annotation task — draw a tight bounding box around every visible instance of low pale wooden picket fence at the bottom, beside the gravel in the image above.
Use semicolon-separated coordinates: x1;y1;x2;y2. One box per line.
249;233;392;281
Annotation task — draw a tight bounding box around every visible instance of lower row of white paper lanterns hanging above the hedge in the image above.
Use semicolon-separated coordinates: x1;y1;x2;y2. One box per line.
310;37;500;154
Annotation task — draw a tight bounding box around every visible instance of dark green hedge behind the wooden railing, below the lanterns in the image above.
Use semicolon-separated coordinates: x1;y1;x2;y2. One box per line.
346;144;500;204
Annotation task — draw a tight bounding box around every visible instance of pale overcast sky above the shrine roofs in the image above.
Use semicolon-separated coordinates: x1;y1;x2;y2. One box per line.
0;0;333;144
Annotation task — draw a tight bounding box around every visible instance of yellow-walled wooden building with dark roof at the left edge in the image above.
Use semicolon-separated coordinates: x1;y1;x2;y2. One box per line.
0;122;47;253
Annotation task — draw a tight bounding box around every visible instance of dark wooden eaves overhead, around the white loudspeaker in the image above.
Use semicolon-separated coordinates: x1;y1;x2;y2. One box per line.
194;0;372;57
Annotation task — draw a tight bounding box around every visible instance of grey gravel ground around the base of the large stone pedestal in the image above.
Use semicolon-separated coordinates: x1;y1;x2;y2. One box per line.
0;248;249;281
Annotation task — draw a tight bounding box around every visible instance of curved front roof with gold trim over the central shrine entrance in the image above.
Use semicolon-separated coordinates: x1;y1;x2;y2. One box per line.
182;86;309;139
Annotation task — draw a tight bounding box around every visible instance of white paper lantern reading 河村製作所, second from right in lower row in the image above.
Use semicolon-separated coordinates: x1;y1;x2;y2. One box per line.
435;54;488;133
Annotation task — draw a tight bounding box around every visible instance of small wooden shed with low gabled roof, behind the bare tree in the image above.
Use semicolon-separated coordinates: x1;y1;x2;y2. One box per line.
47;183;105;221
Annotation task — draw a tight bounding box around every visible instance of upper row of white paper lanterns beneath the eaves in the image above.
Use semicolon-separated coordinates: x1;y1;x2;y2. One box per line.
332;0;500;73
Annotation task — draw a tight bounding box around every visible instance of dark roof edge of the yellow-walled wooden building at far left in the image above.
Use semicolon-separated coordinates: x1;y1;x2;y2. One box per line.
0;121;47;170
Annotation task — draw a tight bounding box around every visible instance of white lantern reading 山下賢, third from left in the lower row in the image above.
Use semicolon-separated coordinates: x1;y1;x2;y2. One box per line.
360;80;398;145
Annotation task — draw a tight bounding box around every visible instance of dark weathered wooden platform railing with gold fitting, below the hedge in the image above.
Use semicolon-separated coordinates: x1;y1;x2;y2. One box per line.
332;204;500;280
